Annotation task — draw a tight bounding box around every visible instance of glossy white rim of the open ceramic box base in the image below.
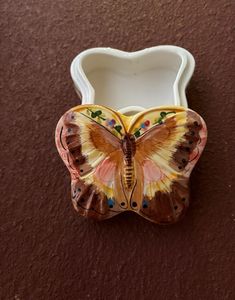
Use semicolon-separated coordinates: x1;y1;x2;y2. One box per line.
70;45;195;113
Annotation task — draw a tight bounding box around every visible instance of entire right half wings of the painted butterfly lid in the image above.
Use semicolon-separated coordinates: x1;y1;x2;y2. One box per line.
128;107;207;224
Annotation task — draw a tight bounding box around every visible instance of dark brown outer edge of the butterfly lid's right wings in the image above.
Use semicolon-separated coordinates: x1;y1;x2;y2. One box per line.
134;110;207;225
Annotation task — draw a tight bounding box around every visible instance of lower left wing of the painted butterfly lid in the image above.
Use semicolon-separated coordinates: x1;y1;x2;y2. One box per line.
71;157;125;220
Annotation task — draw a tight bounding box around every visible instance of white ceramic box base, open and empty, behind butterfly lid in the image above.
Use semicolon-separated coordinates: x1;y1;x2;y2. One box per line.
71;46;195;115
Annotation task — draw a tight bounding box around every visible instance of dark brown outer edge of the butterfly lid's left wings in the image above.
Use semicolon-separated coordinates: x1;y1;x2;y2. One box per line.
55;111;124;220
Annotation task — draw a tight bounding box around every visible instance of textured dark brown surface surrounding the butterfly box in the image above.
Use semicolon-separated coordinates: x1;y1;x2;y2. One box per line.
0;0;235;300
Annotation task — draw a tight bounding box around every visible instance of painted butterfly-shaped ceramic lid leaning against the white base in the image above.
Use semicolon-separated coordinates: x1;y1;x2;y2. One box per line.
56;105;207;224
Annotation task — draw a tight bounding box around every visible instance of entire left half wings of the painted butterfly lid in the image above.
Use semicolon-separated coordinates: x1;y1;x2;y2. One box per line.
56;105;126;220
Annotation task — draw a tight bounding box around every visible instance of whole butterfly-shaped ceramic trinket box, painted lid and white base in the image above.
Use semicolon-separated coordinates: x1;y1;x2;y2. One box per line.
55;46;207;224
